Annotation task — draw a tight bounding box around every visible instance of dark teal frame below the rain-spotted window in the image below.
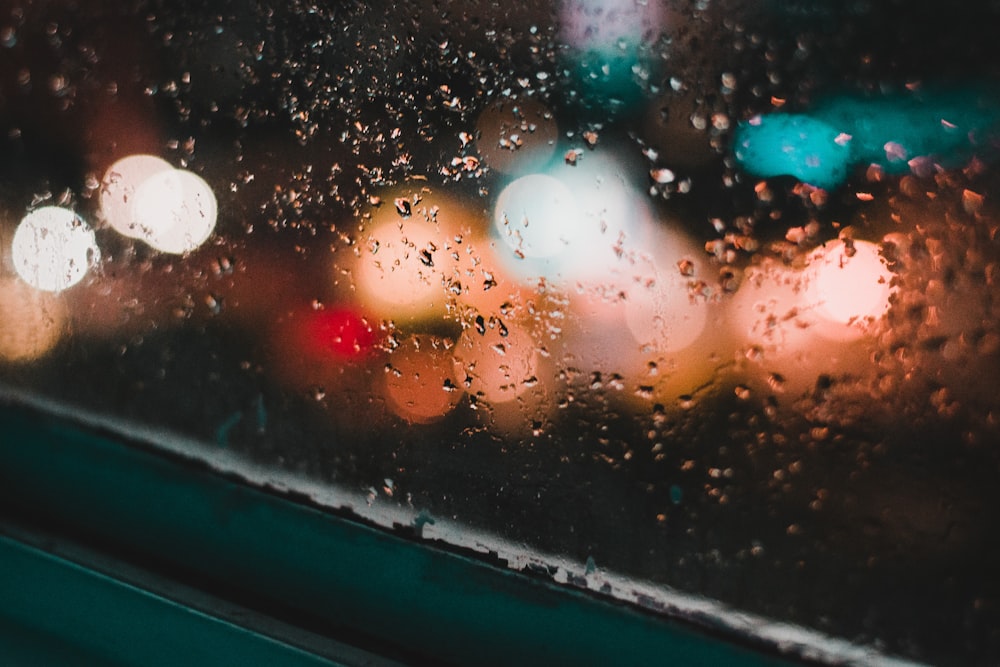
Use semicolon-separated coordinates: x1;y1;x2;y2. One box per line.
0;399;806;667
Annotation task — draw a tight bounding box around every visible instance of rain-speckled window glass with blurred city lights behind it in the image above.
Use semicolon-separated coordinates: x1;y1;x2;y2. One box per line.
0;0;1000;664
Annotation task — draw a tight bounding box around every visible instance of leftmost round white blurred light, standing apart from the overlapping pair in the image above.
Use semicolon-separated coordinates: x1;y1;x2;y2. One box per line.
11;206;99;292
